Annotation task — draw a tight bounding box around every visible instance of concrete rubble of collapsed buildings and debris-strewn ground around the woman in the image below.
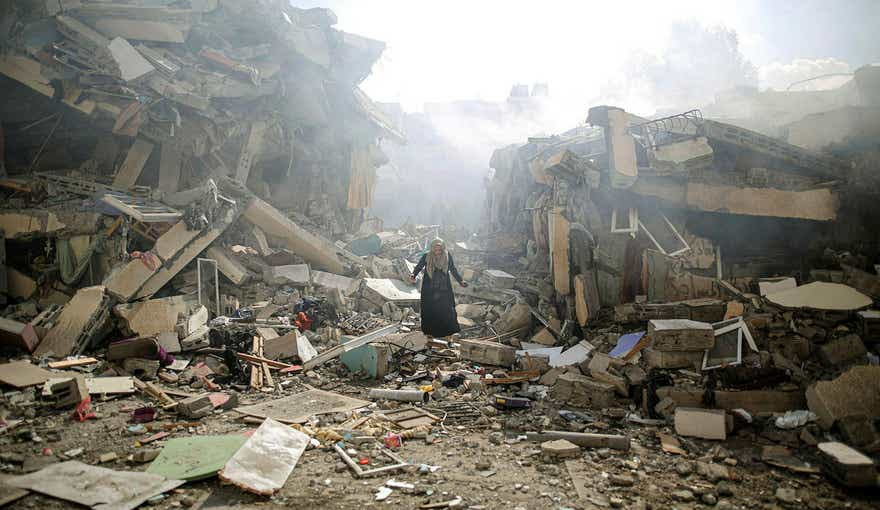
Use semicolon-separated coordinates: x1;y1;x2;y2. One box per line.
0;0;880;509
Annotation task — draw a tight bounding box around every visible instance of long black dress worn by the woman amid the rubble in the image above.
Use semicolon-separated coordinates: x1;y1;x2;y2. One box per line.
413;253;461;338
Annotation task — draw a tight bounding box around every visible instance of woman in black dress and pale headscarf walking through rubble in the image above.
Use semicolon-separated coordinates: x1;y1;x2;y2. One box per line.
410;239;468;338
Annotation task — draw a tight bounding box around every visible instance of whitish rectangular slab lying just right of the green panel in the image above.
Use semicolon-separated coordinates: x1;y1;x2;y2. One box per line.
218;418;310;496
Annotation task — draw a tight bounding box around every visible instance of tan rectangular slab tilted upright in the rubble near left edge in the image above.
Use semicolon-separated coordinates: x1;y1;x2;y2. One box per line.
34;285;110;358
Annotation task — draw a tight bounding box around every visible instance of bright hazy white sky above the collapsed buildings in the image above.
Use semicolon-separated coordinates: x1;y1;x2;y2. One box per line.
292;0;880;111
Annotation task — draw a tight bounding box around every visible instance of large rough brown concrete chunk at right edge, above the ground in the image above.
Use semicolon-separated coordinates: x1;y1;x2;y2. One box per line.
806;366;880;430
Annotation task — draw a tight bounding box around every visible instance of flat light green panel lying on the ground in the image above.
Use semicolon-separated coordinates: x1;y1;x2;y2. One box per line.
147;434;248;482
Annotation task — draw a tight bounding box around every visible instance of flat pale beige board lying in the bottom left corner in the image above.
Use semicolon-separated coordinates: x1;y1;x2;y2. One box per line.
5;460;183;510
